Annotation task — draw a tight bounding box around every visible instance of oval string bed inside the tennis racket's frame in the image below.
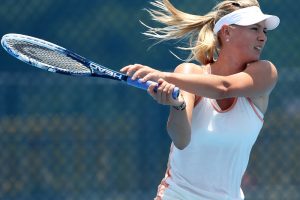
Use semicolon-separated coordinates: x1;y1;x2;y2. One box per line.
7;40;91;74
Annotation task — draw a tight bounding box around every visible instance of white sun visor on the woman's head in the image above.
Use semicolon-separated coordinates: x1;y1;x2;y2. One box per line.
214;6;280;34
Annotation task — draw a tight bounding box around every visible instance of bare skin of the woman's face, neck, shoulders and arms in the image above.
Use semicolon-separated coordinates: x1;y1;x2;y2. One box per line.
121;21;278;149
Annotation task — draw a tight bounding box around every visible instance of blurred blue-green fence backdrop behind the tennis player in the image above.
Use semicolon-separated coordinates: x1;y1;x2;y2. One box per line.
0;0;300;200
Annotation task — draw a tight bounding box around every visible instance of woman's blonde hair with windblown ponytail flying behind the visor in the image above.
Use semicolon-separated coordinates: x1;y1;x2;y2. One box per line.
144;0;259;64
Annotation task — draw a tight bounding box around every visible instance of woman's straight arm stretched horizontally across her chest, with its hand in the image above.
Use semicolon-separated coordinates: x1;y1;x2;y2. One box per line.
120;61;278;99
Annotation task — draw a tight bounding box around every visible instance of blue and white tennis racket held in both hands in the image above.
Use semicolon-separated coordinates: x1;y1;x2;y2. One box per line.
1;34;179;99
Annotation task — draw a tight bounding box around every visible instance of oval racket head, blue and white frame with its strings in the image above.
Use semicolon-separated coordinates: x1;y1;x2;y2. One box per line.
1;33;92;75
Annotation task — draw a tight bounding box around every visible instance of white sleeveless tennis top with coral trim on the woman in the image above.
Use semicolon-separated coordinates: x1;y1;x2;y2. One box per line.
159;97;263;200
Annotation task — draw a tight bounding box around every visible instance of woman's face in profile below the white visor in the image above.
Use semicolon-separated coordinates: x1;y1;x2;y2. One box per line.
225;21;267;62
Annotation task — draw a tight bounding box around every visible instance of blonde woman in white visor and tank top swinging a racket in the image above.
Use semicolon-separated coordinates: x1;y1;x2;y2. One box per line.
121;0;279;200
